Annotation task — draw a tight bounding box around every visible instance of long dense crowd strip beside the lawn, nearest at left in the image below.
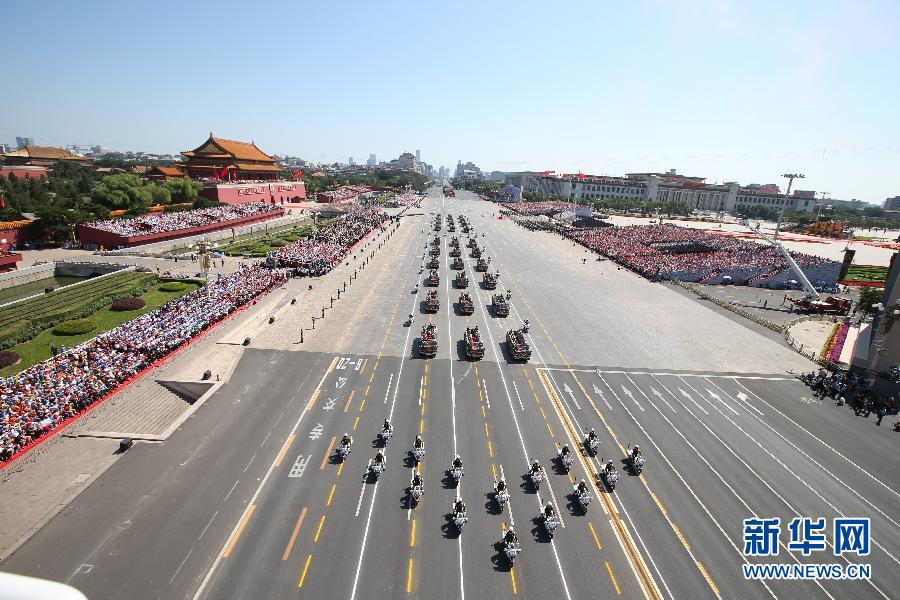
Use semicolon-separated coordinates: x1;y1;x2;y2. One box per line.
0;267;285;462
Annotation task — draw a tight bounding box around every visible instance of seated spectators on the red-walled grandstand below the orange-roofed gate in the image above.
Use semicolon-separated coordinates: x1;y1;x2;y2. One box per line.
85;202;280;237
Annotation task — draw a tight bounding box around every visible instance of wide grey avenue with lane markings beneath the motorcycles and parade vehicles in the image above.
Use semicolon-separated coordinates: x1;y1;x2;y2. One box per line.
4;191;900;600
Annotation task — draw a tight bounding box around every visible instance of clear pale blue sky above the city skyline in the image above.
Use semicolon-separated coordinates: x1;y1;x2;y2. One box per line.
0;0;900;203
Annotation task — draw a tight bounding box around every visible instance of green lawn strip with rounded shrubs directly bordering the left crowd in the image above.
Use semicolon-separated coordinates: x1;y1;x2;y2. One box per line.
0;283;199;377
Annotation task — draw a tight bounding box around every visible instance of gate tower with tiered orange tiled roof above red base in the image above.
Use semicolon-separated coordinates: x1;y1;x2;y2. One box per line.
173;133;284;181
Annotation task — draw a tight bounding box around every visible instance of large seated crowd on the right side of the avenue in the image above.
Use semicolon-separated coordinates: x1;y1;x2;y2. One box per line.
565;224;831;281
